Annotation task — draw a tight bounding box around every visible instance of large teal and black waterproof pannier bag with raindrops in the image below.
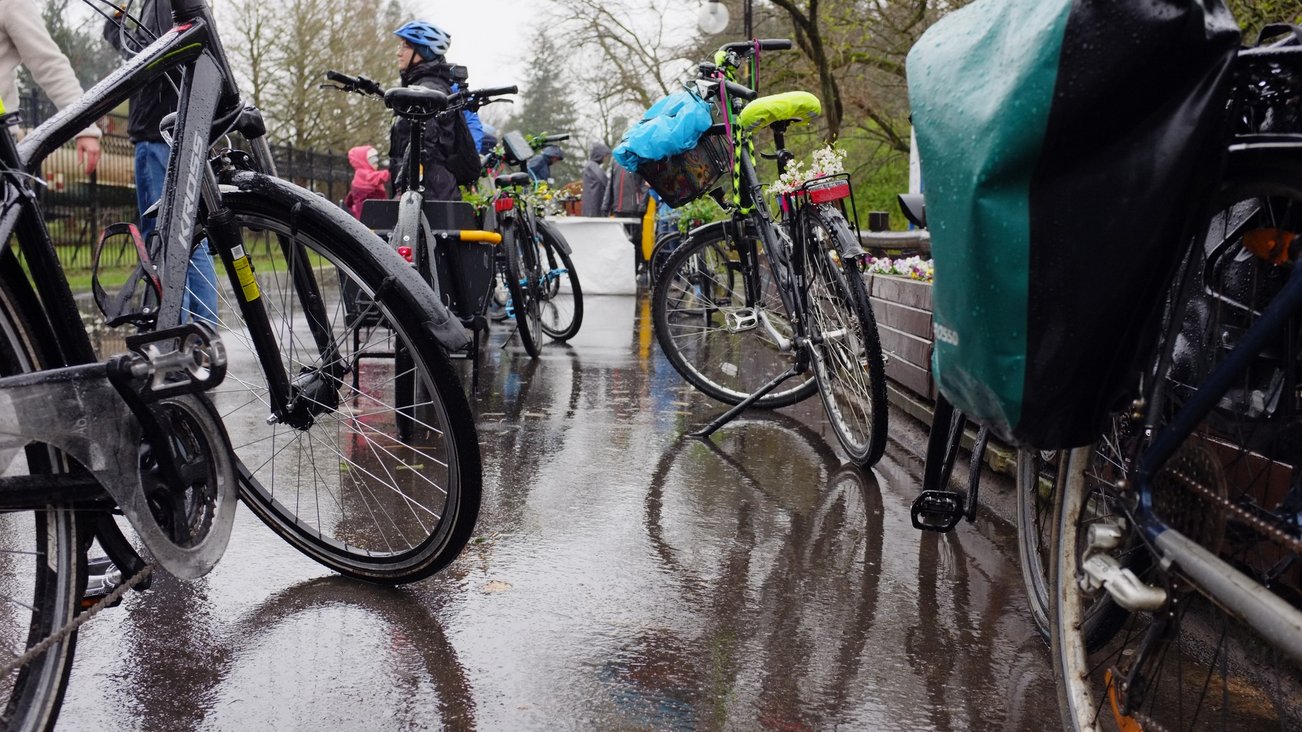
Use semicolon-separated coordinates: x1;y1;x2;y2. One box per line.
907;0;1238;448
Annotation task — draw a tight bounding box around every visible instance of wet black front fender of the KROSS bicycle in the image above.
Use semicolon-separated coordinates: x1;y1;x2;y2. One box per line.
220;171;471;350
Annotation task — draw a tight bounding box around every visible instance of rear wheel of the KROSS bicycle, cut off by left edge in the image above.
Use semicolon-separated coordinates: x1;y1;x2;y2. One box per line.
0;246;90;729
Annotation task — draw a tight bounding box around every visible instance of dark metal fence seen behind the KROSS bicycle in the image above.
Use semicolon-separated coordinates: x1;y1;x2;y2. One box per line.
20;92;353;270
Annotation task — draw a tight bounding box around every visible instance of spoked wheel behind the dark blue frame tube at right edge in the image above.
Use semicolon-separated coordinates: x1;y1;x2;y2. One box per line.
1052;151;1302;729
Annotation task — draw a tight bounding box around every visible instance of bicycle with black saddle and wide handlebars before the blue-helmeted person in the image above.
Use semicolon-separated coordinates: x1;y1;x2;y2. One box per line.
322;70;518;375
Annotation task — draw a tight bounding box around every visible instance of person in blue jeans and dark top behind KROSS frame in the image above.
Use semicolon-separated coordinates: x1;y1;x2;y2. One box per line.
104;0;217;324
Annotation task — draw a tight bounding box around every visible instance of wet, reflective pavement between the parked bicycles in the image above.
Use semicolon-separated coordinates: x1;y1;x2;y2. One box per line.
60;291;1057;731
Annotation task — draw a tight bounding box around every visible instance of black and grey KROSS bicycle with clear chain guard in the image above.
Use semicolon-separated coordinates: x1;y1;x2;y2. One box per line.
0;0;480;728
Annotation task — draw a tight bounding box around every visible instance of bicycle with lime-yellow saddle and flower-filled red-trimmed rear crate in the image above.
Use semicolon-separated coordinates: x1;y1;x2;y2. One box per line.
648;40;887;466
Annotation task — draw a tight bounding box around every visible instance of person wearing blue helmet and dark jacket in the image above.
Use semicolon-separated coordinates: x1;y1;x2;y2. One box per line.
389;21;461;201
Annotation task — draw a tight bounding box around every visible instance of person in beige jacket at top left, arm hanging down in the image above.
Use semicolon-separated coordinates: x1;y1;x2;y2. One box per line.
0;0;100;175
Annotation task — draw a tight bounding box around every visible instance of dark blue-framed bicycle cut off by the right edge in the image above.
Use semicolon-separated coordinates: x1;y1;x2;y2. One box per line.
1049;39;1302;729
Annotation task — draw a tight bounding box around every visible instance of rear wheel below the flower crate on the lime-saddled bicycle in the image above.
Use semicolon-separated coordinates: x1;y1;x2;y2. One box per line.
801;206;888;469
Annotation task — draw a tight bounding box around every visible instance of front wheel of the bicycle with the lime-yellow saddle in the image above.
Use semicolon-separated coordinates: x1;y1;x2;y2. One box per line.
651;221;818;409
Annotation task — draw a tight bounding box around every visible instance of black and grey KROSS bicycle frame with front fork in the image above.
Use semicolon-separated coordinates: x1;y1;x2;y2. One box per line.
0;0;341;422
